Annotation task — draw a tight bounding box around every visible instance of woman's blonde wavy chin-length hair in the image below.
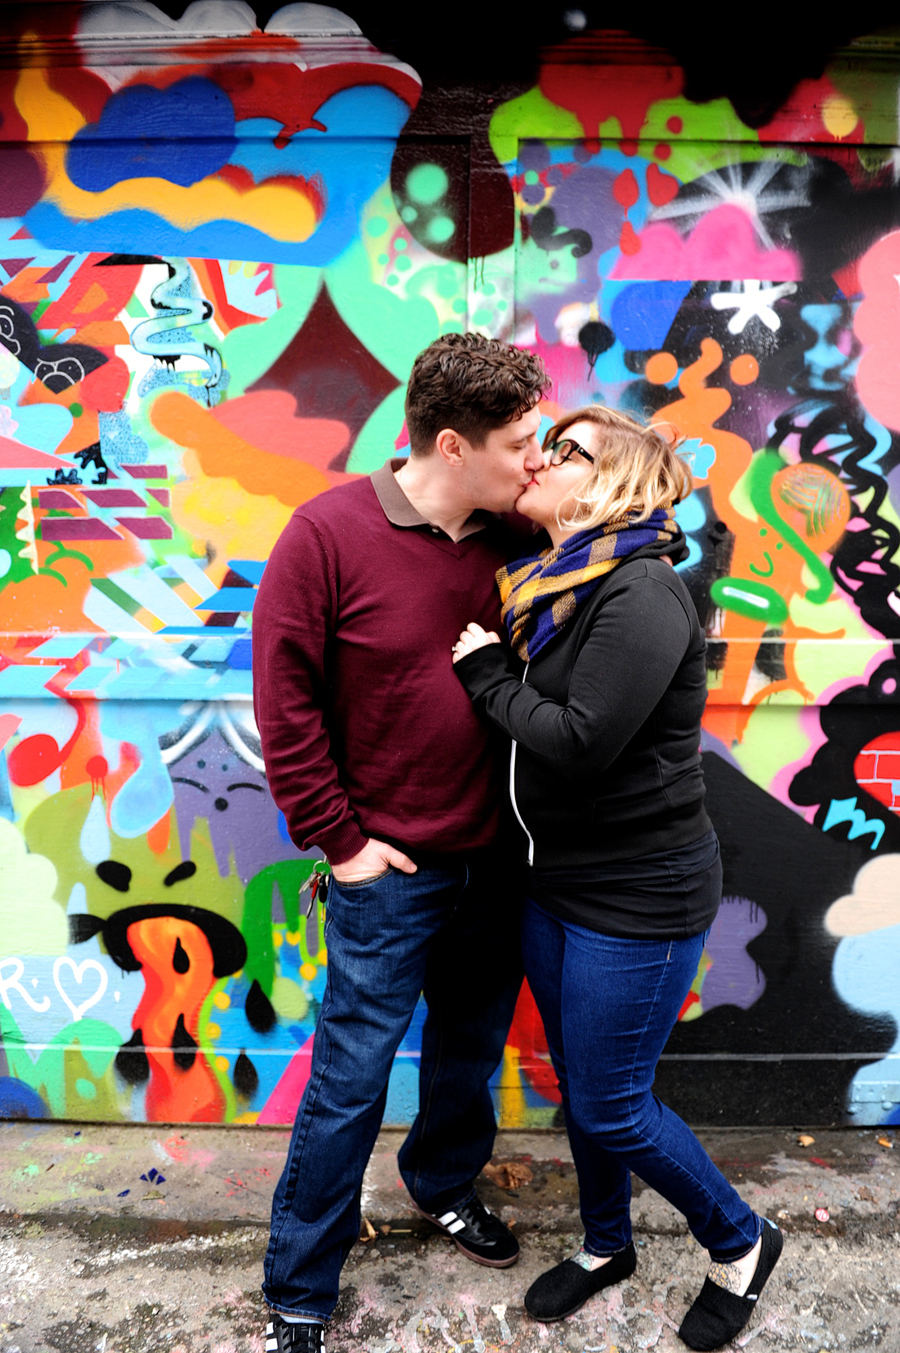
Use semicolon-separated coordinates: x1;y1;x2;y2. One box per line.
544;405;694;530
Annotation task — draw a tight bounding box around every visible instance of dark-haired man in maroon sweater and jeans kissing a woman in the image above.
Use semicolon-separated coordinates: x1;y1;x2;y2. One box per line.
253;334;548;1353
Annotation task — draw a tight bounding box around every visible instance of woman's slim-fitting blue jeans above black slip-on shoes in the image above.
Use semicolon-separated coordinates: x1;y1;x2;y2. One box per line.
522;900;761;1262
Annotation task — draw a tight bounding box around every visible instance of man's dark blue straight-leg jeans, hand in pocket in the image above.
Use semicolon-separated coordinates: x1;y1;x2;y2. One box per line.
263;851;522;1319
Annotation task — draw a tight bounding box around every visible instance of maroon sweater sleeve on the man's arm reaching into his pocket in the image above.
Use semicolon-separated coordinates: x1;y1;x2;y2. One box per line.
253;515;367;865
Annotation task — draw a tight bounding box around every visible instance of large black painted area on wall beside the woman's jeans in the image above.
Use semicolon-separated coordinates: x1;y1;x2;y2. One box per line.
655;752;895;1126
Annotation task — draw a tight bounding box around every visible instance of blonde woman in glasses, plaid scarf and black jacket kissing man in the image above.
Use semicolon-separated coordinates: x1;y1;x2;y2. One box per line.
453;405;782;1349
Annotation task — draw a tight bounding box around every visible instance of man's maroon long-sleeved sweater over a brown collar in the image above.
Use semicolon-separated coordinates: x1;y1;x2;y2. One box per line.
253;461;522;865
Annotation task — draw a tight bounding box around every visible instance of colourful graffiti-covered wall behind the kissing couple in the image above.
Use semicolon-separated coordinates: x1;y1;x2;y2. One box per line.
0;0;900;1126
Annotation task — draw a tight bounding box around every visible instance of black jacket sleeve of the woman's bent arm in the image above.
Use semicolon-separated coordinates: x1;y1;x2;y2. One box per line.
455;576;692;774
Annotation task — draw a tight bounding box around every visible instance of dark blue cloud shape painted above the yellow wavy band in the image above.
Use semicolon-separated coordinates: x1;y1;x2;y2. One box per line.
66;76;235;192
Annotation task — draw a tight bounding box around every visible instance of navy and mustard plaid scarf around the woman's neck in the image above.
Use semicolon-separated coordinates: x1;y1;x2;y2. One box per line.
497;507;679;662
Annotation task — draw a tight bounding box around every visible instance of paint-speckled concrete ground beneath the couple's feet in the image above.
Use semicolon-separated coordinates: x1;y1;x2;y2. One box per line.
0;1123;900;1353
